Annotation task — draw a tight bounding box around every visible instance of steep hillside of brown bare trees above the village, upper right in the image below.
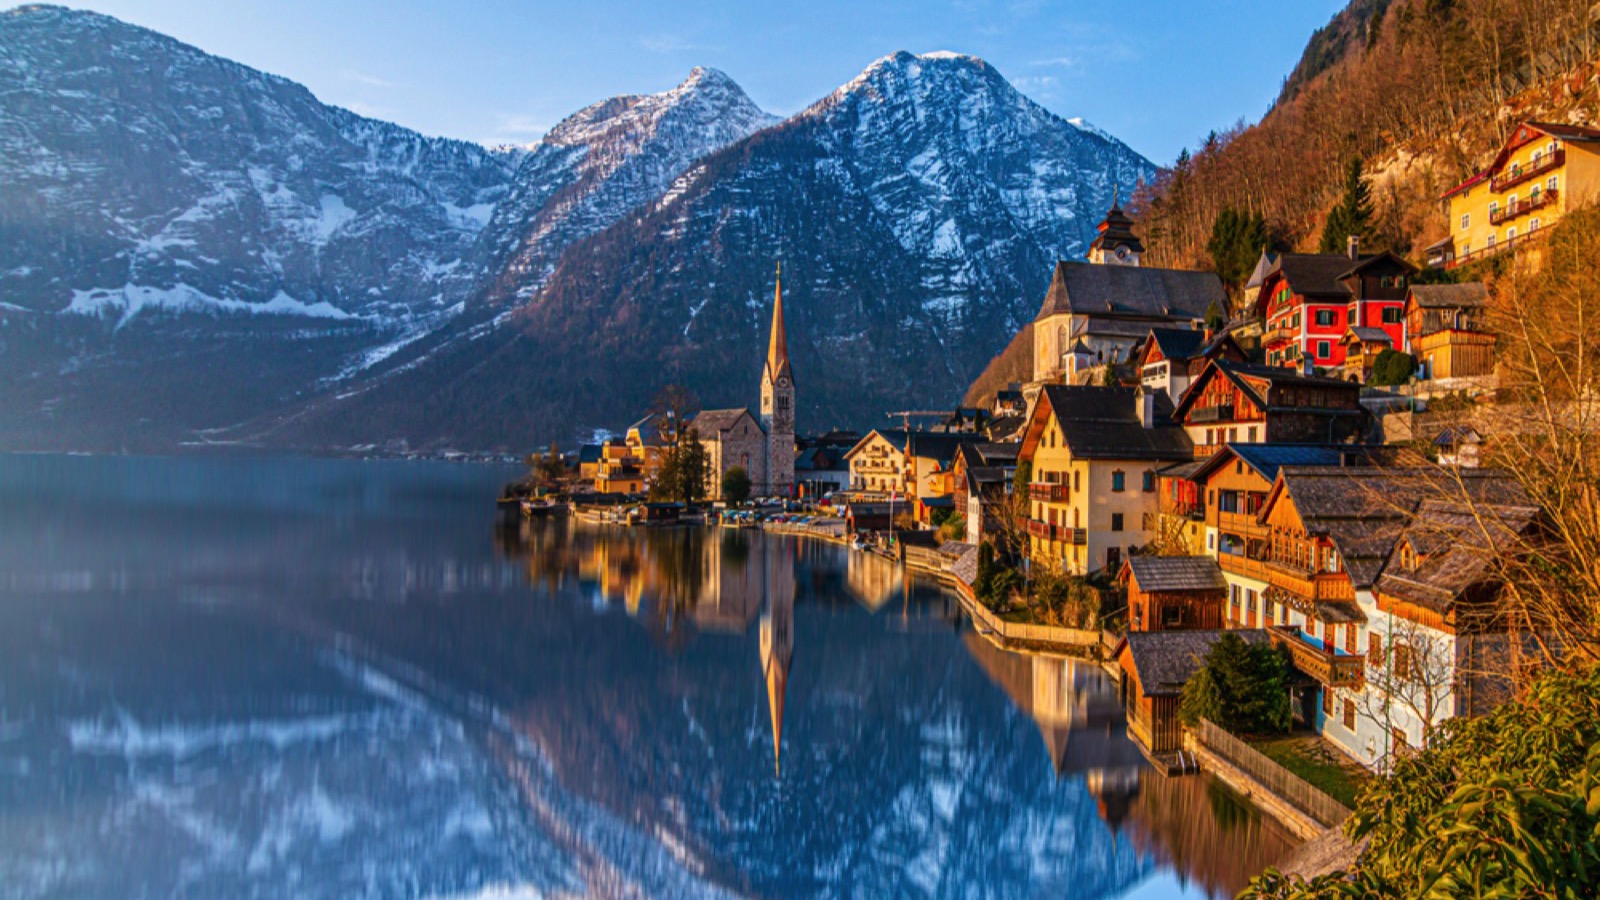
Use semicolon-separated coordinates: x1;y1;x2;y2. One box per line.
1134;0;1600;277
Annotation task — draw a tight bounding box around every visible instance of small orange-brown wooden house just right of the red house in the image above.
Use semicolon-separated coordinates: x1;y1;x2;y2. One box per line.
1405;282;1494;380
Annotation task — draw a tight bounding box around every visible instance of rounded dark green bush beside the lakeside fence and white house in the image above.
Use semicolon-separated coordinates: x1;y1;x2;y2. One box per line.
1178;633;1290;733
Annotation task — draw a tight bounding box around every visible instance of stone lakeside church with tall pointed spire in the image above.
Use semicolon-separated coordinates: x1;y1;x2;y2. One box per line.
690;262;795;500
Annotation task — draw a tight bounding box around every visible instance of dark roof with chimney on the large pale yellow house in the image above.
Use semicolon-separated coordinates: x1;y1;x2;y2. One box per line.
1043;384;1194;461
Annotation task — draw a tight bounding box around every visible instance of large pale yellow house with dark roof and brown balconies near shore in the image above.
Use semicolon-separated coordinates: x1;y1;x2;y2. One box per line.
1018;384;1194;575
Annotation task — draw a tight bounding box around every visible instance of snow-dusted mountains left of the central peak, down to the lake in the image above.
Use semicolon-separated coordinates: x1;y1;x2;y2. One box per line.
0;6;773;450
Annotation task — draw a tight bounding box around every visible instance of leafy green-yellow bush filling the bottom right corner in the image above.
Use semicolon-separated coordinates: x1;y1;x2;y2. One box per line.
1240;666;1600;900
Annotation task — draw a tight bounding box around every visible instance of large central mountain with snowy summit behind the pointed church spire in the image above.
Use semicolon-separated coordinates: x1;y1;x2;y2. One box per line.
281;51;1155;448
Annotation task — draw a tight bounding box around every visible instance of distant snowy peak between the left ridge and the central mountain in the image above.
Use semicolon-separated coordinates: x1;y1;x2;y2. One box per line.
485;66;778;301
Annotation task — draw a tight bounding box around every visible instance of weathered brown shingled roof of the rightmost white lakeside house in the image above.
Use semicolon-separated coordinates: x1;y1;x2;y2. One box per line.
1378;498;1539;613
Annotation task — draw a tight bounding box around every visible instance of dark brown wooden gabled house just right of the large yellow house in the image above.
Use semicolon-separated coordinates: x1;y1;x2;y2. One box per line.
1174;359;1371;458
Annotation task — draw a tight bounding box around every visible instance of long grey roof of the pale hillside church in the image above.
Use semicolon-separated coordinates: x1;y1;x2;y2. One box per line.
1038;259;1227;320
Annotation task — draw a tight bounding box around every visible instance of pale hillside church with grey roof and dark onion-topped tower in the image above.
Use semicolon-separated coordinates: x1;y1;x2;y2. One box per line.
1034;205;1227;384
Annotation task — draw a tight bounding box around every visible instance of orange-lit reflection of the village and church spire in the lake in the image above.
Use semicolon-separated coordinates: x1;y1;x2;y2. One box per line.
496;525;1296;897
